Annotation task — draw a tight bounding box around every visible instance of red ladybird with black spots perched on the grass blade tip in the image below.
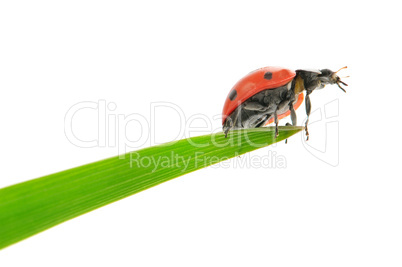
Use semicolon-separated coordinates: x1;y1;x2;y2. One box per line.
222;67;347;140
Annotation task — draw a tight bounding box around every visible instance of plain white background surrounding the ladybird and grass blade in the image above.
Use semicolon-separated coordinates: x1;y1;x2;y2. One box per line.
0;0;402;267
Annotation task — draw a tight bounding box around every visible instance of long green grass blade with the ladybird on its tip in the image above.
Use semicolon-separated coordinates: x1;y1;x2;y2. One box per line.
0;127;303;249
